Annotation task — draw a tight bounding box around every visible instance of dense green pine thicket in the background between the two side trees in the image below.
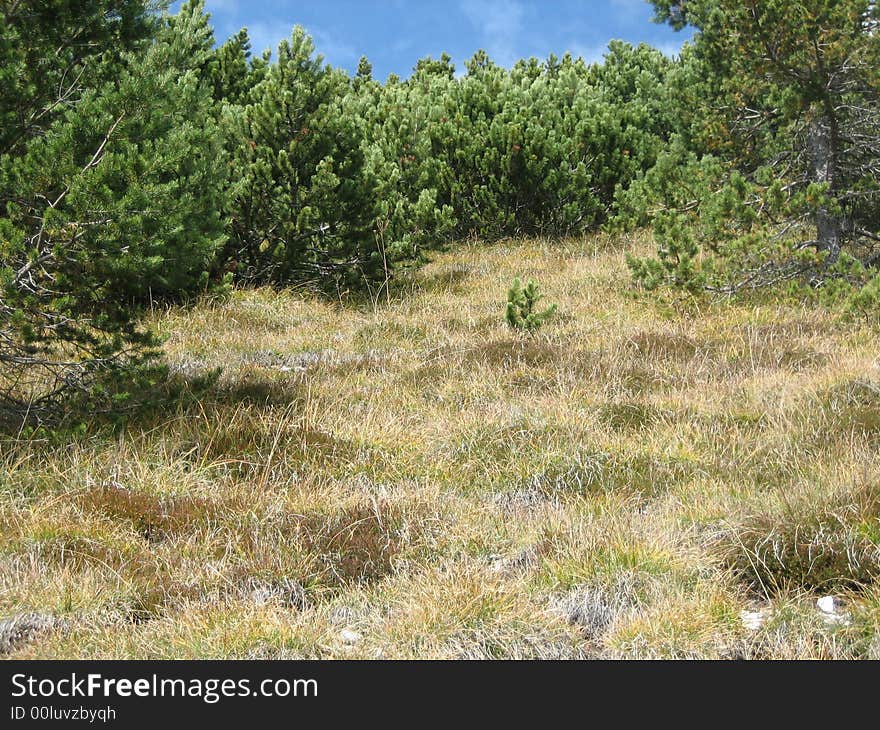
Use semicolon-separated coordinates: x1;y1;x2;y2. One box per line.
210;29;674;289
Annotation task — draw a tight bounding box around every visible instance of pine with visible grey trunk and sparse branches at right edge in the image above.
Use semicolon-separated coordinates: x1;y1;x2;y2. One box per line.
632;0;880;292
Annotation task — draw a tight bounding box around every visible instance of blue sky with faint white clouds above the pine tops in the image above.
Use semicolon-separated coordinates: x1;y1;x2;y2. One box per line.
187;0;689;79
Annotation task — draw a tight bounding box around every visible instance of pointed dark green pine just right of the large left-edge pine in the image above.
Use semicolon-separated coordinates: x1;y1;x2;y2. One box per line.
225;28;385;290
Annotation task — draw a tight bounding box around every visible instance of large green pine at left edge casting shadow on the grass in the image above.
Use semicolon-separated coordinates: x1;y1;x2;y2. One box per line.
0;2;226;412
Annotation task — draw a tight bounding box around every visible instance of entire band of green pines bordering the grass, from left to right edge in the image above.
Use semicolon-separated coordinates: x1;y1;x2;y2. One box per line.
0;0;880;416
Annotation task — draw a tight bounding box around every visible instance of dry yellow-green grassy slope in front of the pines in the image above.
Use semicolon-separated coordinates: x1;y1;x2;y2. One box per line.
0;238;880;658
